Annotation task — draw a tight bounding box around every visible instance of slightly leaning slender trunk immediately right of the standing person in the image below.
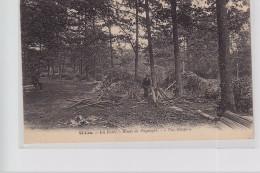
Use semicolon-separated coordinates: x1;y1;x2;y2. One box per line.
145;0;156;103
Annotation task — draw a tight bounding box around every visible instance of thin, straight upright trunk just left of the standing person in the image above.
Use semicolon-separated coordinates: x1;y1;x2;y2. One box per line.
135;0;139;79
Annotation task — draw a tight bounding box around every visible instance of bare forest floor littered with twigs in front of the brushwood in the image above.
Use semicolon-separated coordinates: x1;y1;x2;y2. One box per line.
24;78;221;129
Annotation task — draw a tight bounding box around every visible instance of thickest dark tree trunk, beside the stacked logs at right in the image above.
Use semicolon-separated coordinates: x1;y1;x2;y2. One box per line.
216;0;235;112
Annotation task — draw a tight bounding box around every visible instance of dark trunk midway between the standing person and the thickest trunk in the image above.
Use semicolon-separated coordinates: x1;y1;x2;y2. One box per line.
171;0;183;96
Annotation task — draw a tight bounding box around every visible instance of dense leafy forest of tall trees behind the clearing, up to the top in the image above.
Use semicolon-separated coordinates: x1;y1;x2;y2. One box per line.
21;0;251;113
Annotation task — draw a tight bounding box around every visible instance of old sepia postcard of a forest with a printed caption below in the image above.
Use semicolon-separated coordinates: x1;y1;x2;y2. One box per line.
20;0;254;144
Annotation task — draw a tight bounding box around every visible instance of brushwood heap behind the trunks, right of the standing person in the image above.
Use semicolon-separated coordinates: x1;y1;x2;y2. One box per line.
162;72;253;112
